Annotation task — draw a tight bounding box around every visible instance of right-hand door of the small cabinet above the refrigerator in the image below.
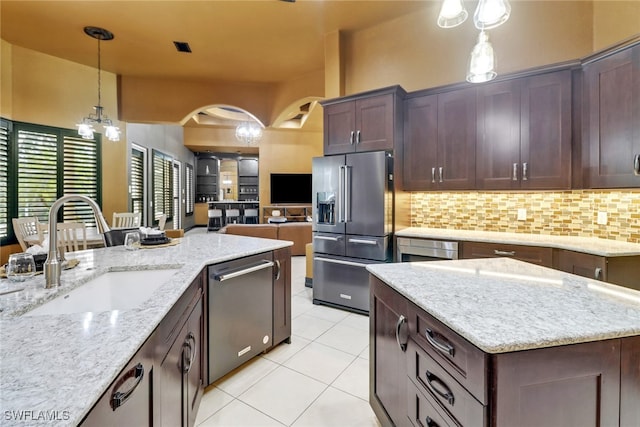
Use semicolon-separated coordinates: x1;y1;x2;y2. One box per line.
354;94;395;151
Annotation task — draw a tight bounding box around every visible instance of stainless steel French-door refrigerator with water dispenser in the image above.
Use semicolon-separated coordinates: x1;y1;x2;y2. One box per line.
312;151;393;313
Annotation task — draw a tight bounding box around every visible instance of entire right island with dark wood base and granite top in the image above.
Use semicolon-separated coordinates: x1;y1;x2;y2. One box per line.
367;258;640;426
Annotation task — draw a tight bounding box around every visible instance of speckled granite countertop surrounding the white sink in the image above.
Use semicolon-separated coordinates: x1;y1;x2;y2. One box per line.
0;233;291;426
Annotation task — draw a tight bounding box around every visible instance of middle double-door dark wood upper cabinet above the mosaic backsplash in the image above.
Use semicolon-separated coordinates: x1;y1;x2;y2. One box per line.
476;70;571;190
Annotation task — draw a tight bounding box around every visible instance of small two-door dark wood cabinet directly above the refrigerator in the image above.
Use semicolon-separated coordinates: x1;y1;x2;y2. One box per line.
322;86;404;155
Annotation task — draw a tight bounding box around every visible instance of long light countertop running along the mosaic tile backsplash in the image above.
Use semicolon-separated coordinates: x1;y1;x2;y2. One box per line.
395;227;640;257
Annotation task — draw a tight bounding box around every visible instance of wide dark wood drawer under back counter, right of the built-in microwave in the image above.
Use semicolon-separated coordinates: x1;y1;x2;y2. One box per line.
461;242;553;267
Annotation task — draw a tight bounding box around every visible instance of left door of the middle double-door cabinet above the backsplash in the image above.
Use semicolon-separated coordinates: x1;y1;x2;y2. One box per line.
476;80;521;190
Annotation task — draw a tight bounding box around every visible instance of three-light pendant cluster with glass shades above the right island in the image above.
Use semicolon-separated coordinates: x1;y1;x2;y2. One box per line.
437;0;511;83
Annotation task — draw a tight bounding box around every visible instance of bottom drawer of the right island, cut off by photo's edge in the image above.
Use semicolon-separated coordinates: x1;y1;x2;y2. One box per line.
407;379;460;427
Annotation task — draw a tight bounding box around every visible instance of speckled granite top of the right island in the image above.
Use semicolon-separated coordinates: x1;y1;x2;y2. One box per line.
367;258;640;353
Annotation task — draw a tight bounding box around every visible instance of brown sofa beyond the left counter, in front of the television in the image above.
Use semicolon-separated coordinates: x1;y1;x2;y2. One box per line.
218;222;311;256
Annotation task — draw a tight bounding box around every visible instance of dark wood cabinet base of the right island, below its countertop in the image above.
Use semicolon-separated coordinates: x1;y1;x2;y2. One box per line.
370;277;640;427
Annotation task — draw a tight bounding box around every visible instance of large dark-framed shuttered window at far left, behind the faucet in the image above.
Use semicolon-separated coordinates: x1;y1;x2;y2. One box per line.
0;120;101;244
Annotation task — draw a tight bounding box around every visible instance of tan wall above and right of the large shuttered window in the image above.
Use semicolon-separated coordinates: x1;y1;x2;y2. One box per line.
0;40;128;226
